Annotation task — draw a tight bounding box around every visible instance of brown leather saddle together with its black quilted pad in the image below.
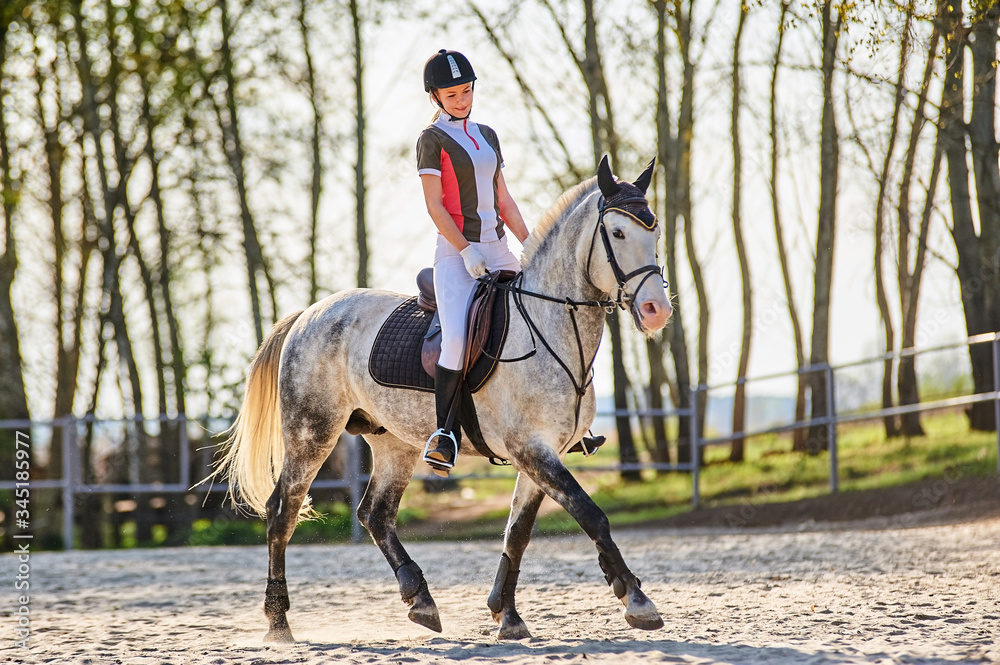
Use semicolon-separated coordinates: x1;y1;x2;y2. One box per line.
368;268;516;393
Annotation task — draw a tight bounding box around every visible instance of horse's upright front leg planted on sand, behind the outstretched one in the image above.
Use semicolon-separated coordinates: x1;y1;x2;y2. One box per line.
486;473;545;640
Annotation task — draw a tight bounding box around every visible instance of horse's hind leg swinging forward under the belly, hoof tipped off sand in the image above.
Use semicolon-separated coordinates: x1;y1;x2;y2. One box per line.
358;433;441;633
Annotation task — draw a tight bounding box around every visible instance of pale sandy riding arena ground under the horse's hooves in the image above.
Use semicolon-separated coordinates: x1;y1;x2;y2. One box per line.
0;519;1000;665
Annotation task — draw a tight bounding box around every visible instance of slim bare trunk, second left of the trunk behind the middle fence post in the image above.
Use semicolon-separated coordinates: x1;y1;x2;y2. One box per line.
729;6;753;462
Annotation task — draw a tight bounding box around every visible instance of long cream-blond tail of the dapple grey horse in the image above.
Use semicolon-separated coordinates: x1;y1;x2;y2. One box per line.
210;310;304;518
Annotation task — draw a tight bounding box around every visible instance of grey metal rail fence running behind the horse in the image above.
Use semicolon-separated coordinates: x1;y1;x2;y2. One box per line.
0;333;1000;550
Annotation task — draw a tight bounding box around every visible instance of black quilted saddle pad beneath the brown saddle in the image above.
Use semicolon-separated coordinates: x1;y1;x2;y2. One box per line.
368;291;510;392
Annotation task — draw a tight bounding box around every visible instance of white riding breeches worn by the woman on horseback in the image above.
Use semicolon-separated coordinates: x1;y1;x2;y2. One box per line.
434;235;521;370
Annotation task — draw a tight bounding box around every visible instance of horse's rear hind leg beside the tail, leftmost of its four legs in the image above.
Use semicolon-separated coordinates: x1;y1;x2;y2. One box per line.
264;418;346;642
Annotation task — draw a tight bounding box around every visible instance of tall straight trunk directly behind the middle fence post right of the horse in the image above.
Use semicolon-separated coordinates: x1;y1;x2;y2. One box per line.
806;0;841;454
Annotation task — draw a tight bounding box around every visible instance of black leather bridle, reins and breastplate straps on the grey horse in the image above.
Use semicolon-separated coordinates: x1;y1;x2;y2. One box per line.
479;195;667;448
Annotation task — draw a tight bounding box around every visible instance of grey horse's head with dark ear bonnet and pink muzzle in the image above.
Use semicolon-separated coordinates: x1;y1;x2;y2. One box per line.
587;157;672;335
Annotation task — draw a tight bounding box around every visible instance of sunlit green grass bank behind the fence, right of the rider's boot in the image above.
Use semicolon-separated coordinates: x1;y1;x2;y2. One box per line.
404;412;997;533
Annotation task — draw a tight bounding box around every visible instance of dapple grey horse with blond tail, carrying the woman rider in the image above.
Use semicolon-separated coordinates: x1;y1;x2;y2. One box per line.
213;158;671;642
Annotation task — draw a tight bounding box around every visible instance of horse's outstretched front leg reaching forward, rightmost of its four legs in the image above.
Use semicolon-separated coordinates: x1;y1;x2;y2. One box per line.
514;439;663;630
